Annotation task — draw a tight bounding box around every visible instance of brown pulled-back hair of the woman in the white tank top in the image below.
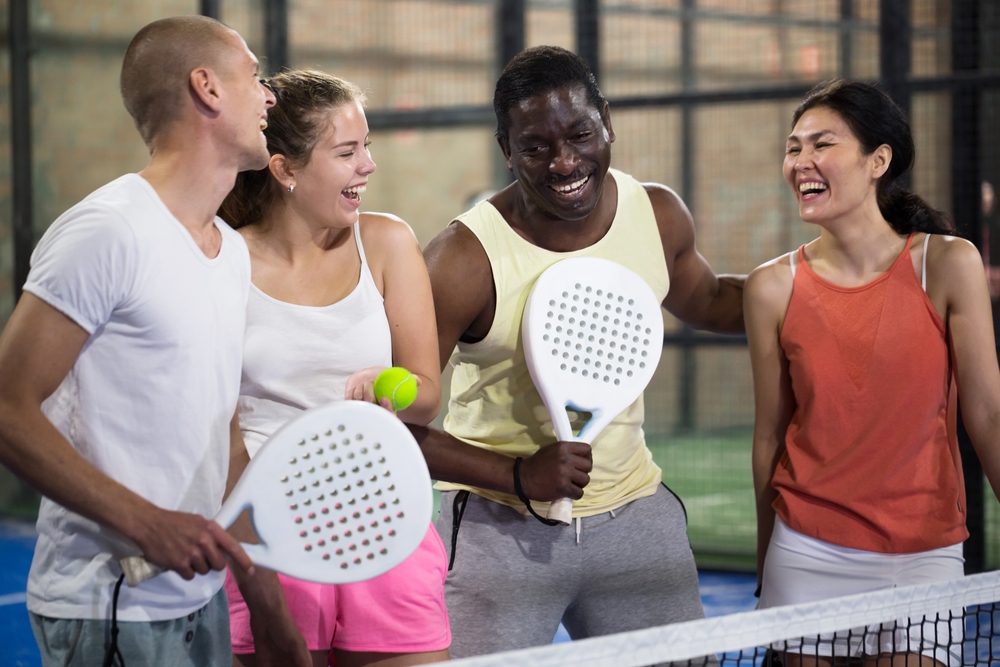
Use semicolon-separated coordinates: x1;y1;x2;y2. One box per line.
219;69;365;229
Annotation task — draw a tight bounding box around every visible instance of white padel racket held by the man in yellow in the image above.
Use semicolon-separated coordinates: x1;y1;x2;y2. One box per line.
521;257;663;524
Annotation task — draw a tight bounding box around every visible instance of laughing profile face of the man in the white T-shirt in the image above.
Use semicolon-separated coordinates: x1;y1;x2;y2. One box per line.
220;32;274;171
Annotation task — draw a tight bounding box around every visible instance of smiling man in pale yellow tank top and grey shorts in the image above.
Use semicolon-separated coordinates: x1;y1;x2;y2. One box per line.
413;47;743;657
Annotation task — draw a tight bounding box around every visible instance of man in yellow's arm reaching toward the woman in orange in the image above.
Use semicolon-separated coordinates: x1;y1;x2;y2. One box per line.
645;183;746;333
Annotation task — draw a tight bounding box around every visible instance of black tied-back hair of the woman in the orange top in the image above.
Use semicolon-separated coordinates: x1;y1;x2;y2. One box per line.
792;79;955;234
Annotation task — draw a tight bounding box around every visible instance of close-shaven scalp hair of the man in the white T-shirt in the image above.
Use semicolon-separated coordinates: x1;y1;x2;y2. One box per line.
121;16;238;146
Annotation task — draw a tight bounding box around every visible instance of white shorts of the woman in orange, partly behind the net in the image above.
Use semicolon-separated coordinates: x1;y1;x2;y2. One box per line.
758;517;965;667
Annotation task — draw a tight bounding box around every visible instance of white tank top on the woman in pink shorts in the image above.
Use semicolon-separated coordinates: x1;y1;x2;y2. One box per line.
239;223;392;456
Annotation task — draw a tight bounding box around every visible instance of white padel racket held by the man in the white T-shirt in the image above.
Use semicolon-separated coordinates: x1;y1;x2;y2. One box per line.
120;401;433;586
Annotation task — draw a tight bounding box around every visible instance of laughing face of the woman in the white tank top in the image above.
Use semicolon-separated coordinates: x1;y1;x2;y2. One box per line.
287;102;375;228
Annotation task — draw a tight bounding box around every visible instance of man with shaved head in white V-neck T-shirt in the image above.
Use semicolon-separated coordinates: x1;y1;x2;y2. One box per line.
0;16;274;665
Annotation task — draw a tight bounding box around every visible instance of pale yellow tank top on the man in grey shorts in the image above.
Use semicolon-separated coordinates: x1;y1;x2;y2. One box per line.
437;169;670;517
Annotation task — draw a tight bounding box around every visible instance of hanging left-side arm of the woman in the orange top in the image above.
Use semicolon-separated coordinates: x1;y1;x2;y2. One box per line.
744;257;795;586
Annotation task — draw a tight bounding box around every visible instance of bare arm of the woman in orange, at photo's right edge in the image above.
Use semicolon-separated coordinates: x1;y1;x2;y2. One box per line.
927;236;1000;497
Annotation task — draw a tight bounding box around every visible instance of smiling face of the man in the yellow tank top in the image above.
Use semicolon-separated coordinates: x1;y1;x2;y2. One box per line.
501;86;615;220
